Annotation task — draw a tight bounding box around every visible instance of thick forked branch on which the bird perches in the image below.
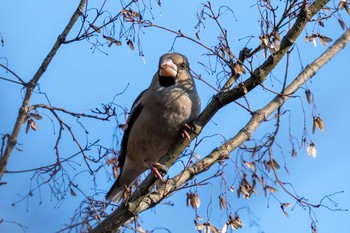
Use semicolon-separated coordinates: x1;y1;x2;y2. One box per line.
92;0;342;233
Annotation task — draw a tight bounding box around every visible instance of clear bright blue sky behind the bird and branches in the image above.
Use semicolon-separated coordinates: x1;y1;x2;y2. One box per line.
0;0;350;233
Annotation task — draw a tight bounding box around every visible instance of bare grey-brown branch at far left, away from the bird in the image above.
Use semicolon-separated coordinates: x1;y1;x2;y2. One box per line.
0;0;87;180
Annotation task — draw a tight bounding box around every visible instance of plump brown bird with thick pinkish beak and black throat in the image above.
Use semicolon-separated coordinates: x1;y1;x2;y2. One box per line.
106;53;201;203
